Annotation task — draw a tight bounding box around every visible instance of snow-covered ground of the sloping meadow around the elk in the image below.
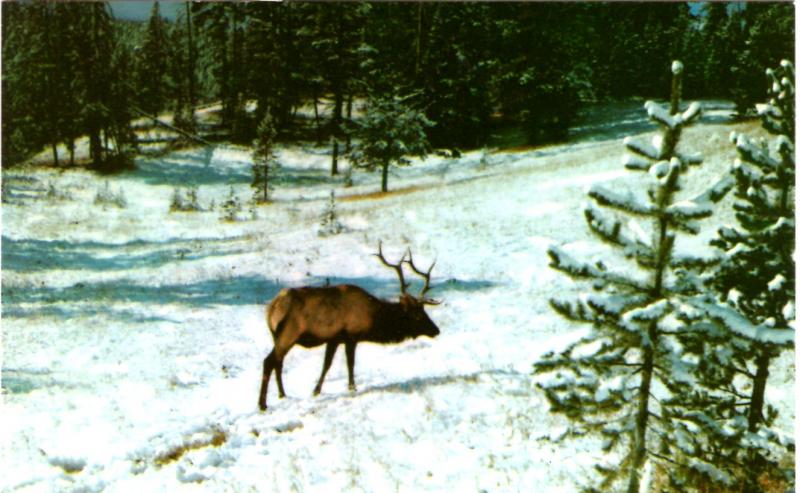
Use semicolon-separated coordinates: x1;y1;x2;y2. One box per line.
0;102;794;492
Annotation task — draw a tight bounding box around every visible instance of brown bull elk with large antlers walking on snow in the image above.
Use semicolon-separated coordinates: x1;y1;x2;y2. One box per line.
258;243;439;411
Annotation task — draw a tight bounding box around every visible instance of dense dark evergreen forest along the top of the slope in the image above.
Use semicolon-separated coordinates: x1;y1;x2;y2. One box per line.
2;2;794;168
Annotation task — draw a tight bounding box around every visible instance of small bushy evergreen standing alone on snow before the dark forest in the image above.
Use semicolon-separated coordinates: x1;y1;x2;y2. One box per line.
350;91;432;192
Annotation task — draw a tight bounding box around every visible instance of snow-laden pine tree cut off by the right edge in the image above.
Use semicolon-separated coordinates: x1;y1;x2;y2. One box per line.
677;61;795;493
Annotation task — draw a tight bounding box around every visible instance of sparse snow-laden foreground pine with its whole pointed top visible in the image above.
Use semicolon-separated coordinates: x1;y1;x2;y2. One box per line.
535;61;732;493
